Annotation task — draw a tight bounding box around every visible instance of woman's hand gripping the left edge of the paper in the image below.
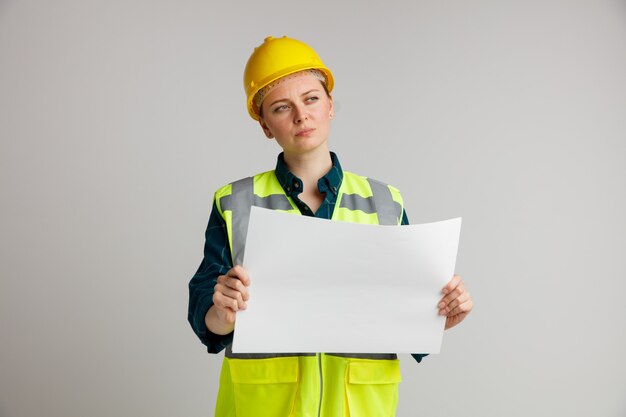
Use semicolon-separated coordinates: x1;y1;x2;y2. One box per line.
213;265;250;326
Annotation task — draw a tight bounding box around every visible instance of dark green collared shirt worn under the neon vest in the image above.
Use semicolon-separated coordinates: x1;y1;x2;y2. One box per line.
187;152;426;362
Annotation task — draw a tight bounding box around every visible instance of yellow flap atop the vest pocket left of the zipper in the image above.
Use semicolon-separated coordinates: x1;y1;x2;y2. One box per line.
228;357;299;384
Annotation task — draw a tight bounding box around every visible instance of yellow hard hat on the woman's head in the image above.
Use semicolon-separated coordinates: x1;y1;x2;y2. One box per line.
243;36;334;120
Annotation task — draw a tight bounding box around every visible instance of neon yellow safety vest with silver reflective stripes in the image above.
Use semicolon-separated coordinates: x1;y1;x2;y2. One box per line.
215;171;403;417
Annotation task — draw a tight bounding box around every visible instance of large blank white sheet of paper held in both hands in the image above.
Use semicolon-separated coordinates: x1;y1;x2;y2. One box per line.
232;207;461;353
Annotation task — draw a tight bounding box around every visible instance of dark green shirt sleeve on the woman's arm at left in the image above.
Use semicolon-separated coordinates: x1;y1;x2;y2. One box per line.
187;201;233;353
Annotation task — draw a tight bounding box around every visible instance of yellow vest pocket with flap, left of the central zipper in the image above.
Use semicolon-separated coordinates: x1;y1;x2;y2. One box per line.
228;357;299;417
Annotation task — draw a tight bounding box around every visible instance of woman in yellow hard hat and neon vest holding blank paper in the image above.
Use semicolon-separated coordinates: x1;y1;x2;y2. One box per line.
189;37;472;417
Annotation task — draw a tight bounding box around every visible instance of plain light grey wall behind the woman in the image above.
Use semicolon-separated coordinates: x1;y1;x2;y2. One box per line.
0;0;626;417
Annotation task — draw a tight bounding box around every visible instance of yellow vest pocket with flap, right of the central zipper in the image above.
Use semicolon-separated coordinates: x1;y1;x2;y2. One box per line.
346;360;402;417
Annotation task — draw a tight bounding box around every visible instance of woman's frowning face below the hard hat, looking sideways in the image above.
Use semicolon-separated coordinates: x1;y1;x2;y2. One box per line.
259;73;333;156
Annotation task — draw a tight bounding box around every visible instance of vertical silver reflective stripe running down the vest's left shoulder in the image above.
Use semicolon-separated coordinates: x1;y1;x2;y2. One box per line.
228;177;254;265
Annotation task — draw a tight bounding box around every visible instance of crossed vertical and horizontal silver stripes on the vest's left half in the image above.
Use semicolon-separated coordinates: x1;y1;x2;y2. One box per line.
220;177;293;265
